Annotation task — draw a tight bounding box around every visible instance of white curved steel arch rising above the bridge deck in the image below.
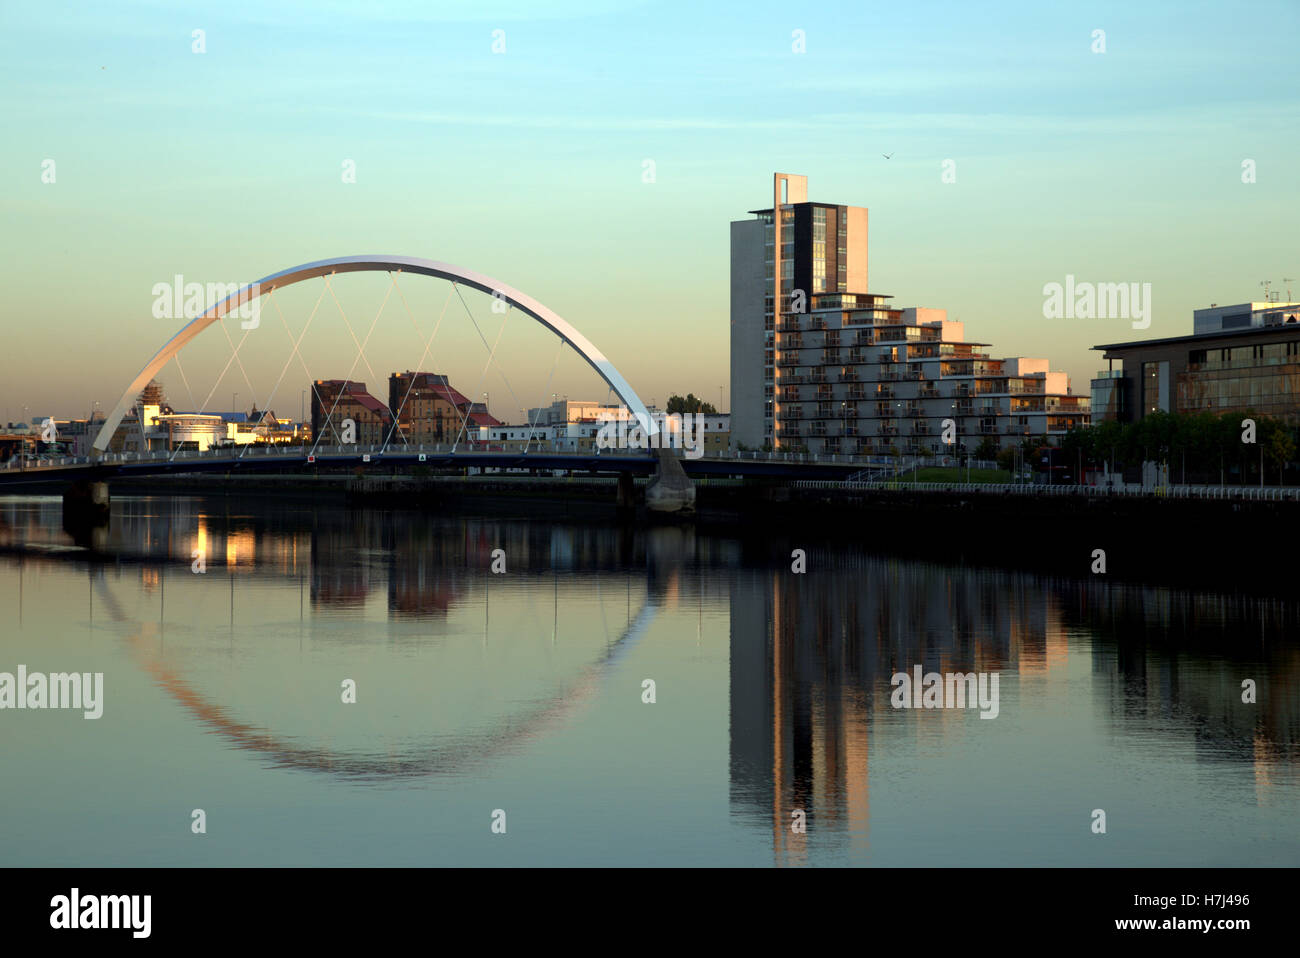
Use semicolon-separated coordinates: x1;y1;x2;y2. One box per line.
95;256;658;452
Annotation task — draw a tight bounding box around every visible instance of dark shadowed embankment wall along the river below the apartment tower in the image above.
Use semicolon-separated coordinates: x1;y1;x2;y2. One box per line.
717;486;1300;591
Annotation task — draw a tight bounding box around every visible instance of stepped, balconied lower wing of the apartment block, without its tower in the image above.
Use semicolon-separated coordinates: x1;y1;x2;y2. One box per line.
775;294;1089;455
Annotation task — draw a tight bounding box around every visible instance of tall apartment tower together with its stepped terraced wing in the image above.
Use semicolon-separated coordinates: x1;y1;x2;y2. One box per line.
731;173;1089;455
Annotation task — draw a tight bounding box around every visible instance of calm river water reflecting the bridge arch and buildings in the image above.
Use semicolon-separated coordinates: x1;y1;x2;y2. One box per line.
0;498;1300;866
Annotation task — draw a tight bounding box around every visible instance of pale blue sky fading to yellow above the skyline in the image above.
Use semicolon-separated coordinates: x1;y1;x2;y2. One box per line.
0;0;1300;420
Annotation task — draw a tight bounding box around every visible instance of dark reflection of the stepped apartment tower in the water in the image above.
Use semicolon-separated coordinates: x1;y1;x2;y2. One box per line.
731;556;1066;863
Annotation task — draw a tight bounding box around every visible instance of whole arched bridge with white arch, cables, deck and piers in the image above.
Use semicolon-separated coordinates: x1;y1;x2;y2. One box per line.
0;256;870;511
